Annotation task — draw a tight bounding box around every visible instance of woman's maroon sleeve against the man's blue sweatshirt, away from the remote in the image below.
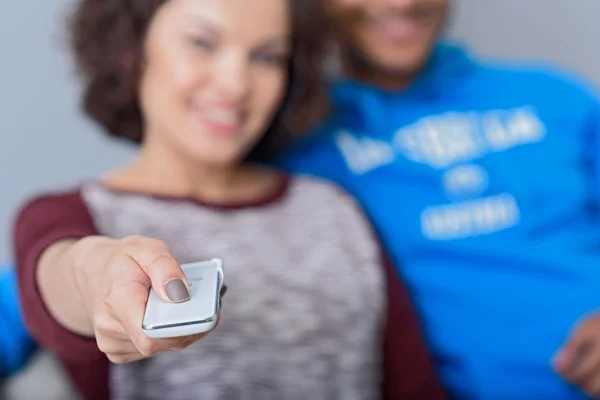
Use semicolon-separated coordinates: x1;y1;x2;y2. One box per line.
384;257;447;400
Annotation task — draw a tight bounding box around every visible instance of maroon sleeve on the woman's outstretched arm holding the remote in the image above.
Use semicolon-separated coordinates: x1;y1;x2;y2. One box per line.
14;191;108;399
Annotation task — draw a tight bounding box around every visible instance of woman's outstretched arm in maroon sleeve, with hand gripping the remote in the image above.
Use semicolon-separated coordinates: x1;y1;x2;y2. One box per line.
15;188;213;362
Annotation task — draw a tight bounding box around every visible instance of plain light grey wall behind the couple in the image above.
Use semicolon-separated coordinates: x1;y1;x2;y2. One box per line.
0;0;600;263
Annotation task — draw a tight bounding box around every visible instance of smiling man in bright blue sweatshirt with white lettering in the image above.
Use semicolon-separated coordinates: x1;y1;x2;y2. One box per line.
282;0;600;400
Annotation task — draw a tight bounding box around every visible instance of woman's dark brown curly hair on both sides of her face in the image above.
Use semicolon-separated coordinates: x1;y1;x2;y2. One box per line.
71;0;328;156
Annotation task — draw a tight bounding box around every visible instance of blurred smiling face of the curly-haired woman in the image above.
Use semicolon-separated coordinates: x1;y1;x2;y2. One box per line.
140;0;291;167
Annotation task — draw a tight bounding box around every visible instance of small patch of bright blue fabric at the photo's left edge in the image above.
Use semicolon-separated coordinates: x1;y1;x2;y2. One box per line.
0;267;35;377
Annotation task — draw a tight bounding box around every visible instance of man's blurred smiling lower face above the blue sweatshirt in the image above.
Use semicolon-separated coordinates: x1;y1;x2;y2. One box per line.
327;0;450;77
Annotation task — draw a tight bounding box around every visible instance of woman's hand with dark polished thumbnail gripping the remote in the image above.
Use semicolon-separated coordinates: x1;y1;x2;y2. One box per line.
70;237;214;363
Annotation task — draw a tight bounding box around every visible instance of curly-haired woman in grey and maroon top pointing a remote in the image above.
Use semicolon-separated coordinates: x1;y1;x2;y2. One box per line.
16;0;443;399
